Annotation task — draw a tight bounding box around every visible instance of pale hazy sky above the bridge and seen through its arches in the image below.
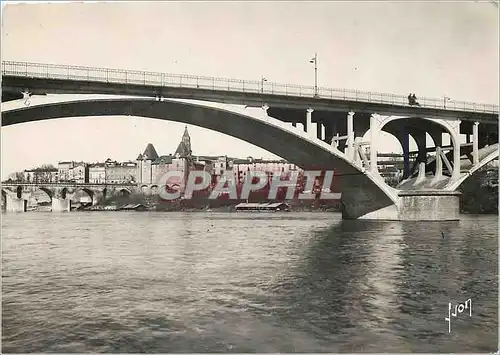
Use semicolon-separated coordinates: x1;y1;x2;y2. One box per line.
1;1;499;179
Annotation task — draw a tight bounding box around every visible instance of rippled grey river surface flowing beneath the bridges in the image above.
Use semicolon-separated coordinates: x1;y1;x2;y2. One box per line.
2;212;498;353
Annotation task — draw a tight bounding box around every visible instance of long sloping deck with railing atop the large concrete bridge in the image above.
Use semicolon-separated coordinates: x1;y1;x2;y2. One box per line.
2;61;499;121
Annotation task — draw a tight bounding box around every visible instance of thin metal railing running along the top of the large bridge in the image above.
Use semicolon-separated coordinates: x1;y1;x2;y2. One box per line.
2;61;499;114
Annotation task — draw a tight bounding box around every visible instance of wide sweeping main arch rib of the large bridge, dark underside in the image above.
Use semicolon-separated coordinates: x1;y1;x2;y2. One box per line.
2;98;398;218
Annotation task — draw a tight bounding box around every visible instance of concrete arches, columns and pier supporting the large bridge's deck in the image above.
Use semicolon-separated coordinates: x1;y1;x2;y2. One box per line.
2;98;498;220
